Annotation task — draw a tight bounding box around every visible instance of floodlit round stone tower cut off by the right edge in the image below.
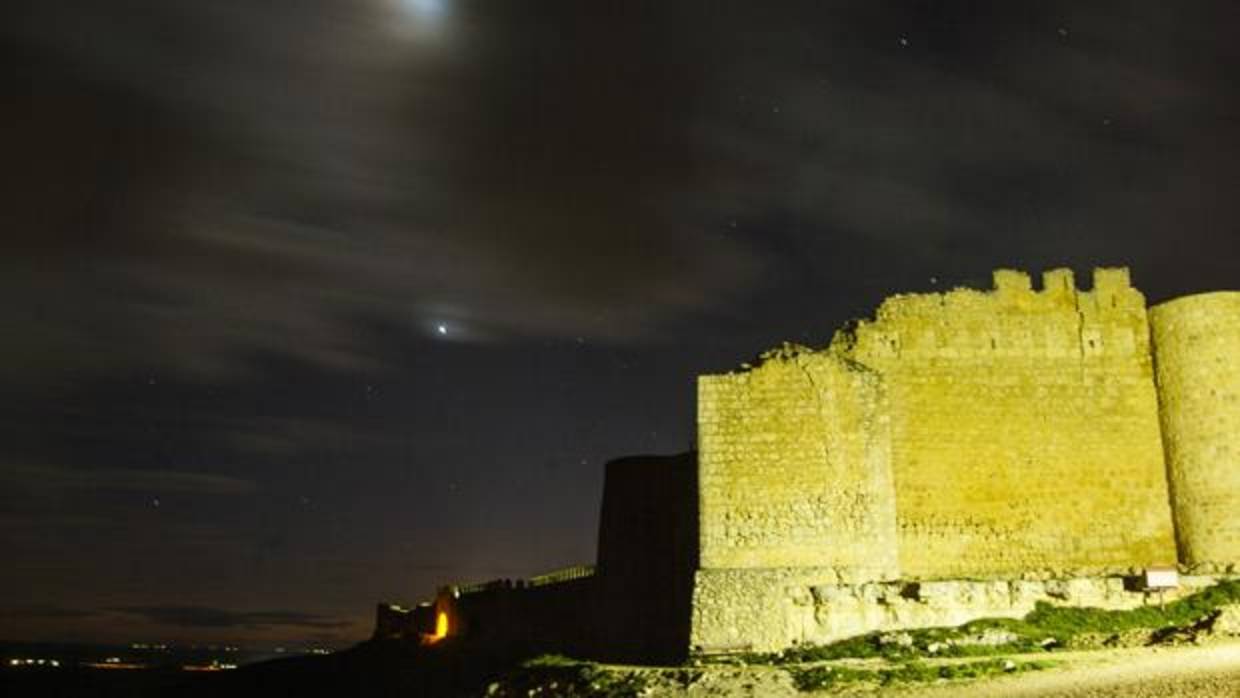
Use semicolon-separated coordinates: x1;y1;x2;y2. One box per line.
1149;291;1240;572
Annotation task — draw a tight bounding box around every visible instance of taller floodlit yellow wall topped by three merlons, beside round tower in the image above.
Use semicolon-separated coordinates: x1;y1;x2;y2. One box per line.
832;269;1176;579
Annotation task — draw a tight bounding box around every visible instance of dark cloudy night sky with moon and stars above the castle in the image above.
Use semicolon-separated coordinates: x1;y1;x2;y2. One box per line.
0;0;1240;643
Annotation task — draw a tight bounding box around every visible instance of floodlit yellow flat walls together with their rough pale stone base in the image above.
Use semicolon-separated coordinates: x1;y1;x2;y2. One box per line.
692;269;1210;651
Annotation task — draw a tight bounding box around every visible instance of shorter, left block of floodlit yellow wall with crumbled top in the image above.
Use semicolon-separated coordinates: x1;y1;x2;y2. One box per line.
698;347;899;580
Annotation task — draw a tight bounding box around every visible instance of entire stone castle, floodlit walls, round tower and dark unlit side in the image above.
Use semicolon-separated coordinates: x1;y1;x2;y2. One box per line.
376;269;1240;661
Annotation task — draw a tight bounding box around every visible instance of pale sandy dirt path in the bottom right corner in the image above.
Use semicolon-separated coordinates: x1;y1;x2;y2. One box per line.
892;642;1240;698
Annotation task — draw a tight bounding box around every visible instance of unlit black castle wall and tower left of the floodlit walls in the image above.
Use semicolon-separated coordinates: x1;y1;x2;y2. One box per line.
421;453;698;663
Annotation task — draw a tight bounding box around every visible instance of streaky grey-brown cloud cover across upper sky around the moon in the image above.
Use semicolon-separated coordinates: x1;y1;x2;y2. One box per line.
2;0;1240;384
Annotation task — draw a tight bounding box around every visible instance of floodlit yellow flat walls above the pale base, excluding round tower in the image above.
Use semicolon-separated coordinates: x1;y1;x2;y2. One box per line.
698;269;1176;587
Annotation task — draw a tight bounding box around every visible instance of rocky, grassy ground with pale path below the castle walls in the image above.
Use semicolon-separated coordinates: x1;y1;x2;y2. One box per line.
484;604;1240;698
